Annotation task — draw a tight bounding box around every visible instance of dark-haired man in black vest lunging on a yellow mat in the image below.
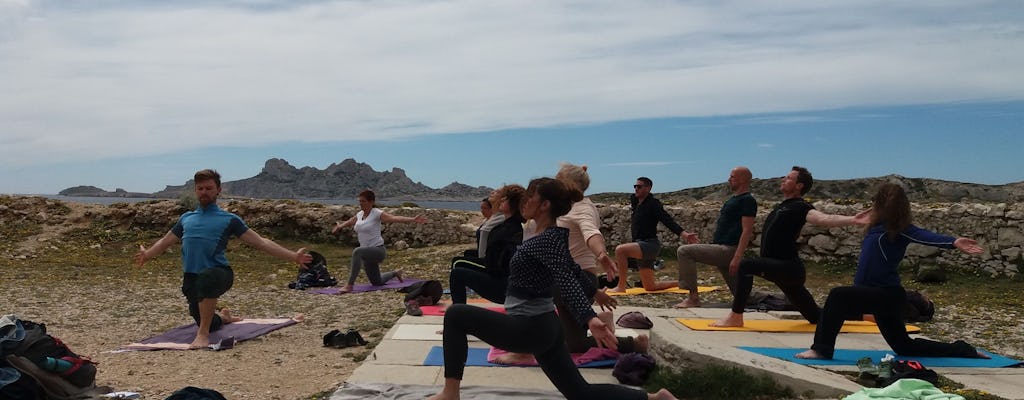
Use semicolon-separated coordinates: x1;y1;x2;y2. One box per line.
711;167;868;326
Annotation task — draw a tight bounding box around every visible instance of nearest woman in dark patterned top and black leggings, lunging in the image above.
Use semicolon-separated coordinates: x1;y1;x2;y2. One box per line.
430;178;676;400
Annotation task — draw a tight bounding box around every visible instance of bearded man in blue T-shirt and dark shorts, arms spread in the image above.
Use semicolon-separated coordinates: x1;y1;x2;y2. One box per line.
134;170;312;349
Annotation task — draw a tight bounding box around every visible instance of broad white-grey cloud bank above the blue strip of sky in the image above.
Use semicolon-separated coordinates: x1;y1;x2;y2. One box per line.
0;0;1024;166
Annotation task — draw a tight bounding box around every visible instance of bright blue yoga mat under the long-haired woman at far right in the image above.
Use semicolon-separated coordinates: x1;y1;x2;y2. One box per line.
737;346;1022;368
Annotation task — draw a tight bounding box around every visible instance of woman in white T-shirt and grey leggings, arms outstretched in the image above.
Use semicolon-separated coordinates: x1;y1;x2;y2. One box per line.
331;190;427;294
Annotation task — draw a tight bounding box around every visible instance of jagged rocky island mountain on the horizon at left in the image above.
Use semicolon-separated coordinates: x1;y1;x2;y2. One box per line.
60;159;494;201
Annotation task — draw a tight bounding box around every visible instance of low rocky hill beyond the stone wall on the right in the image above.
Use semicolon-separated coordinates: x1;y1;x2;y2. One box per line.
591;175;1024;204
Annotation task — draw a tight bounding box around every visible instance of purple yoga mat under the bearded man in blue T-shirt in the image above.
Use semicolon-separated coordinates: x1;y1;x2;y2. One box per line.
119;318;298;351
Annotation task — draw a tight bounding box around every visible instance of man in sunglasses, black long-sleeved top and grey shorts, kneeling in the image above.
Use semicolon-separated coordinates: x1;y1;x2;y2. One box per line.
608;176;697;293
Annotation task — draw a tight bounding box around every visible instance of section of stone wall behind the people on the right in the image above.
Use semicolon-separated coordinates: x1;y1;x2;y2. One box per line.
598;202;1024;277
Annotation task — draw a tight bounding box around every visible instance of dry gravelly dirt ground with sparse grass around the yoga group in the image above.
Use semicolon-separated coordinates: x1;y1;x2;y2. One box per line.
0;198;1024;399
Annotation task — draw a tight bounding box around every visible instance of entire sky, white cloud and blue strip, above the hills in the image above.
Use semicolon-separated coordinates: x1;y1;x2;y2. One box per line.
0;0;1024;193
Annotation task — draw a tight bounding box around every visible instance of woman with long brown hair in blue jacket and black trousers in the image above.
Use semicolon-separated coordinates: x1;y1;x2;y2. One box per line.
796;183;989;359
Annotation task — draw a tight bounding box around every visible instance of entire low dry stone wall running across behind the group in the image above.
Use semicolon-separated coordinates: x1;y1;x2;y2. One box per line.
0;196;1024;277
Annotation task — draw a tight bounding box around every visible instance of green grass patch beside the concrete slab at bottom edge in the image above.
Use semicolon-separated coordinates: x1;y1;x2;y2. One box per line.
644;364;797;400
